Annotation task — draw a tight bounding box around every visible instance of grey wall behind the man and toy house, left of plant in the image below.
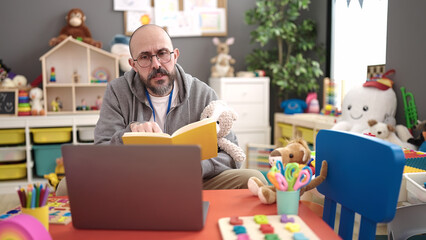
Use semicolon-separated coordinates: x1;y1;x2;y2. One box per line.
0;0;256;85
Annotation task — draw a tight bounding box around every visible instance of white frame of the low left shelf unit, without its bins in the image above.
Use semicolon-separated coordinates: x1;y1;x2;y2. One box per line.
0;113;99;193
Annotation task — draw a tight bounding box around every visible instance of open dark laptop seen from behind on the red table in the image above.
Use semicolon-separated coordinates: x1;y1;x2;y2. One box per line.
62;144;209;231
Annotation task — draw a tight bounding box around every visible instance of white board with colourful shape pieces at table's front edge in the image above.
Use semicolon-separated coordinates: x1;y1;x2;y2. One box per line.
218;214;319;240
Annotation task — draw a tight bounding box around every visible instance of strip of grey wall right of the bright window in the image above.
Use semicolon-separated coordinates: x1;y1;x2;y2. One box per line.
386;0;426;124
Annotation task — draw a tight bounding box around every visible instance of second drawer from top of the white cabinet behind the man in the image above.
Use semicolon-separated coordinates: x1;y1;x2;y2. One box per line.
232;103;269;128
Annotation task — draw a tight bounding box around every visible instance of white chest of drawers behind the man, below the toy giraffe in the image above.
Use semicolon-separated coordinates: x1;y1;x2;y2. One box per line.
209;77;271;153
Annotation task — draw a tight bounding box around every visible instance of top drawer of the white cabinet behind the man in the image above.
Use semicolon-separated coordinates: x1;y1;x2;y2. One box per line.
221;83;266;103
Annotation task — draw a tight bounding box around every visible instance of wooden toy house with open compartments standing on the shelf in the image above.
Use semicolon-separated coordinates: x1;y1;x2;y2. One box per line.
40;36;119;115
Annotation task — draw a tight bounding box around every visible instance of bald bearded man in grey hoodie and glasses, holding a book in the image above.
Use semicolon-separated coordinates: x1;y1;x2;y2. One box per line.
89;25;267;189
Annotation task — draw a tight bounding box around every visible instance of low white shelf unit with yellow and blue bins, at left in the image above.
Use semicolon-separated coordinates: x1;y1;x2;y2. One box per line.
0;113;99;193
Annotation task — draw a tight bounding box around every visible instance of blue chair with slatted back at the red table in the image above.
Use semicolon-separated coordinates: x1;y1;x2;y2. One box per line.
315;130;405;239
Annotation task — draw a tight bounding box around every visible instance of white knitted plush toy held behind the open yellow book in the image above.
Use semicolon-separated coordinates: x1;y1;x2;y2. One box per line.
201;100;246;162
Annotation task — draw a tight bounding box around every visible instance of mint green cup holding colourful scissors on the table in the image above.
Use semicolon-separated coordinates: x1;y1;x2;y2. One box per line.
277;190;300;215
